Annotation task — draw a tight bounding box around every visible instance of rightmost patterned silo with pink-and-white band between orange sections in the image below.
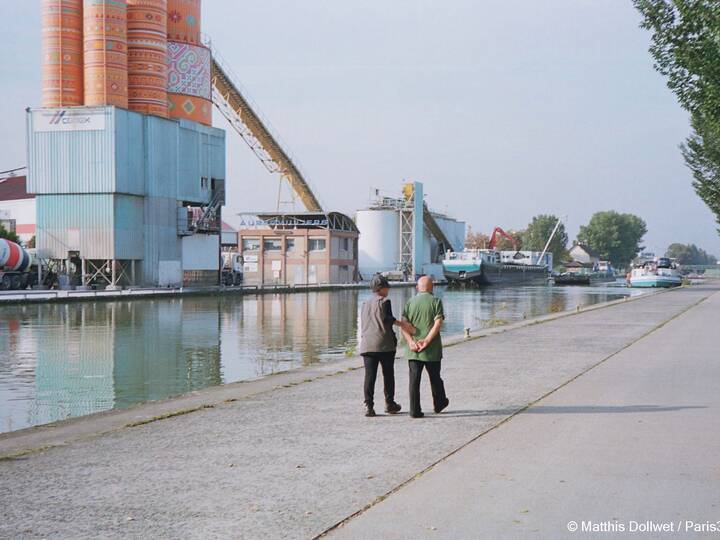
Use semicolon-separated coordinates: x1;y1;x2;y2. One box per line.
168;0;212;126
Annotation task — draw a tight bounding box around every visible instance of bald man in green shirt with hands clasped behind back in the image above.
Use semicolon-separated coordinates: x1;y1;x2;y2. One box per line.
403;276;450;418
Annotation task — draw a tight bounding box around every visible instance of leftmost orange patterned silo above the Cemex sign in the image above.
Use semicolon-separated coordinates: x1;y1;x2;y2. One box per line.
42;0;84;107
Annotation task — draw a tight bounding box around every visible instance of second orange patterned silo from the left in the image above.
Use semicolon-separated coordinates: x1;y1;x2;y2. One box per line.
83;0;128;109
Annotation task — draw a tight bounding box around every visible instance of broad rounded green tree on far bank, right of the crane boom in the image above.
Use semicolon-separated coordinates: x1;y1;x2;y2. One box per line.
578;210;647;268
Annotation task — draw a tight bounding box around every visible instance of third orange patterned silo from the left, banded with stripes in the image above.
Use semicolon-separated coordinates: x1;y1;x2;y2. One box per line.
127;0;168;118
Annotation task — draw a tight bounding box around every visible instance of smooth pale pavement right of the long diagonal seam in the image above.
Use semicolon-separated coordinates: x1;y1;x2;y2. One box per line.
330;284;720;540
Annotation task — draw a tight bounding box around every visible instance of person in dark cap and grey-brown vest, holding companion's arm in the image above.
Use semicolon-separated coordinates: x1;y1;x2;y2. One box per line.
360;274;415;416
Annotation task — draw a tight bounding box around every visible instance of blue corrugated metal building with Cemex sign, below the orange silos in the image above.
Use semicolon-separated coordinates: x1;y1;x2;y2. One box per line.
27;107;225;286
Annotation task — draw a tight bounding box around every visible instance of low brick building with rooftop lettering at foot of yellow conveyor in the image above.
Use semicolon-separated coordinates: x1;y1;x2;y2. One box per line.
238;212;358;285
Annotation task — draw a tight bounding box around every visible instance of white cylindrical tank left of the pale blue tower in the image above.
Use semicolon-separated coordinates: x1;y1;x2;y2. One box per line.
355;209;400;278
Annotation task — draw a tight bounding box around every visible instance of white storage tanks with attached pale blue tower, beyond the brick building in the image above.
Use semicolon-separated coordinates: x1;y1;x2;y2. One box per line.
355;182;465;279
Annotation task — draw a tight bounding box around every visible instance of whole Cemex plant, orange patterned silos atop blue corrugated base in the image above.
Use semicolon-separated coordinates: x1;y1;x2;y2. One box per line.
27;0;225;288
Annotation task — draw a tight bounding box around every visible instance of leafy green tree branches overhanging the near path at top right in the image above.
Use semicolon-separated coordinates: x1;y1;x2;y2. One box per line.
633;0;720;233
